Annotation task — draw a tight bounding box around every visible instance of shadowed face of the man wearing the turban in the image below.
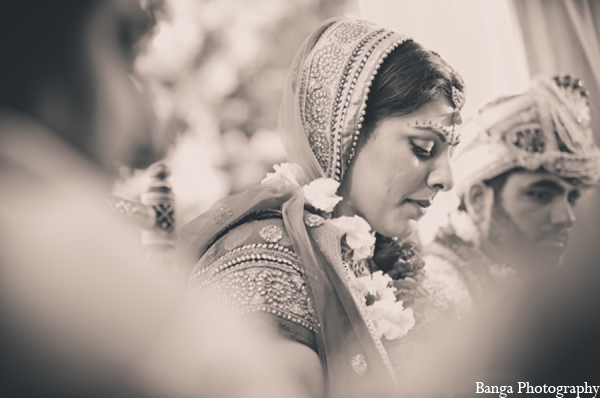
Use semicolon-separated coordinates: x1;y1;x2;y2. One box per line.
488;171;581;271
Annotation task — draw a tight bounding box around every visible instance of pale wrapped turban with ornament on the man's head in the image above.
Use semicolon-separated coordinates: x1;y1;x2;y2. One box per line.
452;76;600;195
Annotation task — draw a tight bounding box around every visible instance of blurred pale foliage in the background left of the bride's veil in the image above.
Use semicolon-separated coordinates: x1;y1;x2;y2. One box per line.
115;0;360;226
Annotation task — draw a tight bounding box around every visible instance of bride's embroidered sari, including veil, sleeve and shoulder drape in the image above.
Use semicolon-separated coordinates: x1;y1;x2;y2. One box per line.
175;19;407;396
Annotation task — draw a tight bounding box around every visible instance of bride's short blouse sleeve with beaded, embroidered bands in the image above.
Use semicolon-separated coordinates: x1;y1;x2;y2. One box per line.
190;218;317;352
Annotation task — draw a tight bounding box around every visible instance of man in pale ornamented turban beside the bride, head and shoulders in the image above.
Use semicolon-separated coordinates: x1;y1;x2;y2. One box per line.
425;76;600;308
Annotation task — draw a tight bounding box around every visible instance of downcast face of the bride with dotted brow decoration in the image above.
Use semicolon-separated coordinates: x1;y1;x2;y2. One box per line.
336;96;454;239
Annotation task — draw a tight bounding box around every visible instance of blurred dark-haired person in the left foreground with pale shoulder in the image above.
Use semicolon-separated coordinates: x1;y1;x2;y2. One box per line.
0;0;304;397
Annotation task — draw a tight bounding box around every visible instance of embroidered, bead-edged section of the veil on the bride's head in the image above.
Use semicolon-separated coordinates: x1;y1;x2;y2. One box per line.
297;19;410;181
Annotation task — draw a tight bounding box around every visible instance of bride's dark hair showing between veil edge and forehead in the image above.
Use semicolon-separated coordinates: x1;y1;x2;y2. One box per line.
361;40;466;136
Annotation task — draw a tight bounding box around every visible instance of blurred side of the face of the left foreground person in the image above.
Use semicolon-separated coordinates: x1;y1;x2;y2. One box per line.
84;0;161;169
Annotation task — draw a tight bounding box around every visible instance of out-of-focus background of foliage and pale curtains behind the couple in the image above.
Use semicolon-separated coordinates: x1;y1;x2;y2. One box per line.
115;0;600;255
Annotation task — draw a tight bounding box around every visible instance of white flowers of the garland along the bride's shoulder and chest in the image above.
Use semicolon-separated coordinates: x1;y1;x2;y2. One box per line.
261;163;415;340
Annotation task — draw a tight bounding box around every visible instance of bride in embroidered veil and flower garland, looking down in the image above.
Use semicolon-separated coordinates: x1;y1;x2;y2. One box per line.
176;18;464;397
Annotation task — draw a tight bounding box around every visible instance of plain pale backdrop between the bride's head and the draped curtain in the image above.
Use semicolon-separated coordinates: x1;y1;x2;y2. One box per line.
360;0;529;243
